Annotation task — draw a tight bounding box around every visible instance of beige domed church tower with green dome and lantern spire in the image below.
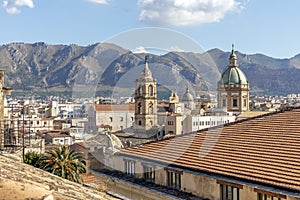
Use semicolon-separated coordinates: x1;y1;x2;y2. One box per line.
218;48;249;114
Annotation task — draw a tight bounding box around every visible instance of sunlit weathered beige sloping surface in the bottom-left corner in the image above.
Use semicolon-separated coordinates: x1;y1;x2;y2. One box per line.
0;155;115;200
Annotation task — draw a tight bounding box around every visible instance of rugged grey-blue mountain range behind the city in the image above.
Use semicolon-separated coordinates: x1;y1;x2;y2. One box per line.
0;42;300;98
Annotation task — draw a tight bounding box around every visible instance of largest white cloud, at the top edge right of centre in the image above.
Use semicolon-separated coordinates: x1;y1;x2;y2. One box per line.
138;0;243;26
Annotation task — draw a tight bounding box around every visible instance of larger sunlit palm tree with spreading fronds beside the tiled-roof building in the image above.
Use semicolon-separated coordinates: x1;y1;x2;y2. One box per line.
44;146;86;184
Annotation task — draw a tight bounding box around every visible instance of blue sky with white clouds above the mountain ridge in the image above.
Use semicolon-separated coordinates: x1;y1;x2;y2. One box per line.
0;0;300;58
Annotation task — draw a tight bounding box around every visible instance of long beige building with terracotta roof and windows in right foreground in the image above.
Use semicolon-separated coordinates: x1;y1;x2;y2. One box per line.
100;109;300;200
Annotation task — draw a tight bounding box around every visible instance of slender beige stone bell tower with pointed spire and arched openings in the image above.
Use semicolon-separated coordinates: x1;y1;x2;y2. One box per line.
134;56;157;137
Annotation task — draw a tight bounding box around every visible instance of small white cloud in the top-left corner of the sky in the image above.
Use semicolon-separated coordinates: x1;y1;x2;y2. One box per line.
2;0;34;15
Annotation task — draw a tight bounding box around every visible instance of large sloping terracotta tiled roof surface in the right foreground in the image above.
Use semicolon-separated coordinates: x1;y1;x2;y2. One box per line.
121;109;300;191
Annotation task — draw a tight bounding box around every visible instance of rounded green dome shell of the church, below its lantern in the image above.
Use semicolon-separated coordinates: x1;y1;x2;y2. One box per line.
221;67;248;84
